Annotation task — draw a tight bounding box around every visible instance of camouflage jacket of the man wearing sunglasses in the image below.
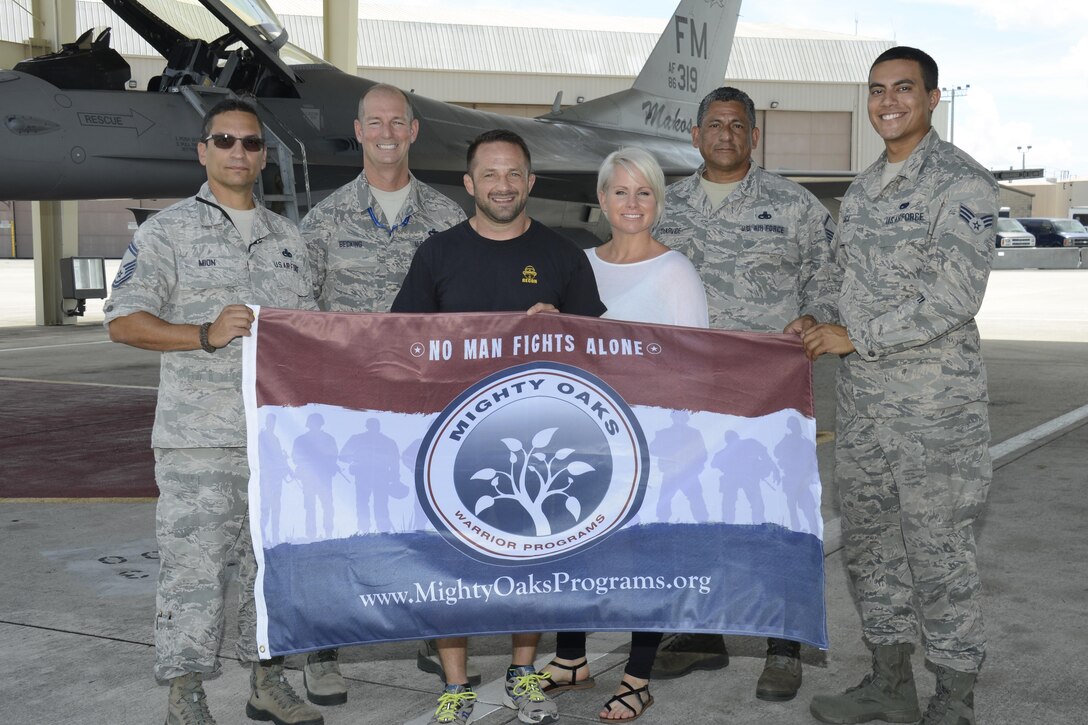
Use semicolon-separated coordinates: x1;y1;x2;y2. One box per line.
104;183;317;448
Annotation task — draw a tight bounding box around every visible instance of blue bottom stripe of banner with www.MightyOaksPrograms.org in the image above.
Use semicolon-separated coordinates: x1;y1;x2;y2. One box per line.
258;524;827;654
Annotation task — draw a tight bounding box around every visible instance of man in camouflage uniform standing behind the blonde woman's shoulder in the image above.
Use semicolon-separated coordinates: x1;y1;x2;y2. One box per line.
654;86;838;701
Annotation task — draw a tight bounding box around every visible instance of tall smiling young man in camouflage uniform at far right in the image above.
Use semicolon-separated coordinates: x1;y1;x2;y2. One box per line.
803;47;998;725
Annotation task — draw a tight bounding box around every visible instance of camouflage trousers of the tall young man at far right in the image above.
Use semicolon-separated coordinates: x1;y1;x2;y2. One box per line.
836;403;992;672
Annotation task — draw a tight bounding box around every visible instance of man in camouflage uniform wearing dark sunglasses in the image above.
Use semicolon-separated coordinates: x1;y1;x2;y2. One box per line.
106;99;324;725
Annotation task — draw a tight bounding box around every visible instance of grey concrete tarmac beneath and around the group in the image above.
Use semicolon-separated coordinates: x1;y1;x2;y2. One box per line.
0;262;1088;725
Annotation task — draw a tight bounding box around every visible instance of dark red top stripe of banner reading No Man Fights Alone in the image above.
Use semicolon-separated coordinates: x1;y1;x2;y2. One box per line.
257;308;814;418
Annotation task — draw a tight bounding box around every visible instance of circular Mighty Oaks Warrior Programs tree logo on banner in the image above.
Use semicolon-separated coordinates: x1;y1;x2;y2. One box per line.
416;363;650;564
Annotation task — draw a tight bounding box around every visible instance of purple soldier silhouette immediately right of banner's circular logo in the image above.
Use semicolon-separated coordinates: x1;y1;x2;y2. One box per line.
650;410;708;523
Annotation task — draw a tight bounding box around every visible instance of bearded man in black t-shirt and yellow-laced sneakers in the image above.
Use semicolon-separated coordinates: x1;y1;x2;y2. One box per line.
393;130;605;725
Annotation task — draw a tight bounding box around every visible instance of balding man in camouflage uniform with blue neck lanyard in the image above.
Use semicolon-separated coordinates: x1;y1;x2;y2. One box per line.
301;83;467;704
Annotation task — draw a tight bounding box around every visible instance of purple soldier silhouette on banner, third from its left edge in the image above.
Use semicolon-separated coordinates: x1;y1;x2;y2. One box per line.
339;418;408;531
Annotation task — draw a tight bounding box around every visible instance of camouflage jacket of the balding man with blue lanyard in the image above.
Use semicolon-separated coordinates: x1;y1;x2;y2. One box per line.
300;173;465;312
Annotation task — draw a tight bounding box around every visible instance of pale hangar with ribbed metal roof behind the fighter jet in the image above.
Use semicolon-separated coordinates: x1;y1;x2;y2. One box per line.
0;0;900;258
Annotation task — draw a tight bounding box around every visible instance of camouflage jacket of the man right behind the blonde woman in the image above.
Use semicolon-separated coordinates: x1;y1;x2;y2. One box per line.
654;163;838;332
